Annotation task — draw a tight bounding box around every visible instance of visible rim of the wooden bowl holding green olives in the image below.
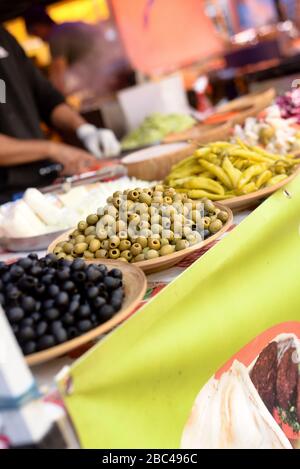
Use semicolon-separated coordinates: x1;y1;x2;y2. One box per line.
48;203;233;274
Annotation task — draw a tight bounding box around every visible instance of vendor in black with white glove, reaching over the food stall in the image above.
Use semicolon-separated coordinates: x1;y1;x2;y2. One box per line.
0;26;120;201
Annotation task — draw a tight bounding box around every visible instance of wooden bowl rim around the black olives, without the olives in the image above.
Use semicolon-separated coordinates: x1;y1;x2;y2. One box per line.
25;259;147;366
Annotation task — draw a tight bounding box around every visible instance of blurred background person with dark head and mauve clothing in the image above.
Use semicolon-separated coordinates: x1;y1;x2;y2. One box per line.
24;5;130;102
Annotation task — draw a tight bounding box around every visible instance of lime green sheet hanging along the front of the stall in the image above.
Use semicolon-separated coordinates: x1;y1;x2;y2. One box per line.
58;177;300;448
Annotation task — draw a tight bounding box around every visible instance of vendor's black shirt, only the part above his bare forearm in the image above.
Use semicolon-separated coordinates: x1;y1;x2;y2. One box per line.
0;27;64;139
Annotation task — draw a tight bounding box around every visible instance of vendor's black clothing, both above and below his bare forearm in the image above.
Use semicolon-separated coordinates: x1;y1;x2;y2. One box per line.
0;26;64;202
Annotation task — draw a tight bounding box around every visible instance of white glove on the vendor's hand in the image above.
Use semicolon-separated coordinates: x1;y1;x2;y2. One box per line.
76;124;121;158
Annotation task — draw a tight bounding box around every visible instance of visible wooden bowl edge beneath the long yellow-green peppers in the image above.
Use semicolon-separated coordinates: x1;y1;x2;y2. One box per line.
221;167;300;212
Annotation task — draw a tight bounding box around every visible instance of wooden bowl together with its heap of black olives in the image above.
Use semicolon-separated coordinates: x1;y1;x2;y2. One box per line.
0;254;147;365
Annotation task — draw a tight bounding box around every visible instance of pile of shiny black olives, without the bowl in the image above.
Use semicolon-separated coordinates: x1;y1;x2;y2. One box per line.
0;254;124;355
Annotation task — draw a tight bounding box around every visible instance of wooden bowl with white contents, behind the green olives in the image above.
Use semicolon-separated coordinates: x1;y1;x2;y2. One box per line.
121;142;197;181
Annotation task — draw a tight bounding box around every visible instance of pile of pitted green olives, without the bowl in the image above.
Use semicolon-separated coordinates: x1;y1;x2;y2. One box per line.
53;185;228;262
